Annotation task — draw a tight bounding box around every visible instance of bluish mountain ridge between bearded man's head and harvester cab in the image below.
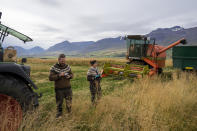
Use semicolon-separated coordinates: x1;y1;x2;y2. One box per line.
46;37;125;55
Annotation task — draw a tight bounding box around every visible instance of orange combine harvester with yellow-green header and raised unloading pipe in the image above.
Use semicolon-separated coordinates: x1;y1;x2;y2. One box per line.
103;35;186;77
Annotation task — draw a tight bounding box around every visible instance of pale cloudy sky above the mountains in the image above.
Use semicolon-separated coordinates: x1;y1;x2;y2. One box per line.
0;0;197;48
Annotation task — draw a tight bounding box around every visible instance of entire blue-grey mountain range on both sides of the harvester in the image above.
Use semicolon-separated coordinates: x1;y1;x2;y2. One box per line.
6;26;197;57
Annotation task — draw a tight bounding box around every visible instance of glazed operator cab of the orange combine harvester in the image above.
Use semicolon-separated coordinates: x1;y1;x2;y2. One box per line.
125;35;155;60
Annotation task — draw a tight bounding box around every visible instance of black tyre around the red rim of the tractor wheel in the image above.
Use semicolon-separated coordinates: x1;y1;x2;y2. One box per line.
0;75;38;111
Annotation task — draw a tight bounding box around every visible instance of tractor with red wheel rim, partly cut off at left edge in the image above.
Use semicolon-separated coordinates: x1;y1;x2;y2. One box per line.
0;12;40;131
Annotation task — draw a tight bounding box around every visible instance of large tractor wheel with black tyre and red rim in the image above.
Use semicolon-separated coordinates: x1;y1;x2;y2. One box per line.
0;75;38;131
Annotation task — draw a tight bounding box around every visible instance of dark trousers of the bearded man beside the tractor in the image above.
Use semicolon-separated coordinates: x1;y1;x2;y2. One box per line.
55;88;72;113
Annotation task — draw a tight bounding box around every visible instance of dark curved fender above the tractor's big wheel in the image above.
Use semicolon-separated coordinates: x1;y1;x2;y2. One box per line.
0;62;38;89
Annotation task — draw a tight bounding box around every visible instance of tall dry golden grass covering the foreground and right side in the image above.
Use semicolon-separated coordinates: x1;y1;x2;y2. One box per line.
20;73;197;131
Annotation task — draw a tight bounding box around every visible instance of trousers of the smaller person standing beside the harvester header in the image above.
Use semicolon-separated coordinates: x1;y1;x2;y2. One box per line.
90;80;102;104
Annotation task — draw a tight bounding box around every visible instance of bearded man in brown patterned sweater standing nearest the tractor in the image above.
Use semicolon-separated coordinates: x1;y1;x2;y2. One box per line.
49;54;73;117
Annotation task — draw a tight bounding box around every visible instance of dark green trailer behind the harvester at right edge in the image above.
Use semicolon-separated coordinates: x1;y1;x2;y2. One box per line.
172;46;197;70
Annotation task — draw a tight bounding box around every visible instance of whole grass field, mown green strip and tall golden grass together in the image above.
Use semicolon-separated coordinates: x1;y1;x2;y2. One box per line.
19;58;197;131
